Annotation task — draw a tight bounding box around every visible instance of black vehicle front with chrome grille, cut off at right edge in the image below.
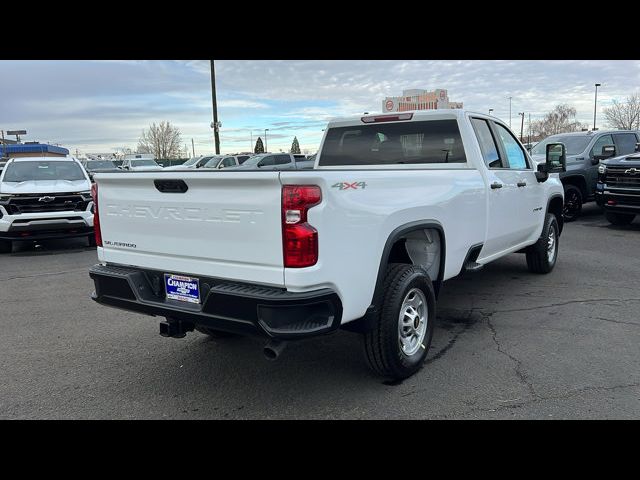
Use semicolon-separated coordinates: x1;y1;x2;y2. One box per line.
596;144;640;225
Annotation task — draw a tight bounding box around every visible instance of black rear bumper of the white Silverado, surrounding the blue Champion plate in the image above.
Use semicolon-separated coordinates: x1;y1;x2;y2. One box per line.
89;265;342;340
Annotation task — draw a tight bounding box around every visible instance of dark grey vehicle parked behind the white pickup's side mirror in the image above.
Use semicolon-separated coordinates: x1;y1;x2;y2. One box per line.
531;130;640;222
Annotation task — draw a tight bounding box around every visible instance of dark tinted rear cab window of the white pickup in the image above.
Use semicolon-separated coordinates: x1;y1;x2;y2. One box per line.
318;119;467;167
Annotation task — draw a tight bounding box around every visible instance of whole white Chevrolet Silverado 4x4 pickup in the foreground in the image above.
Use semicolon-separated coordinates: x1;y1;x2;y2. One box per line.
90;110;565;379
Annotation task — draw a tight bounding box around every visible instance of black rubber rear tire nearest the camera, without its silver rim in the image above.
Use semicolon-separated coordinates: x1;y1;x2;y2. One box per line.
364;264;436;380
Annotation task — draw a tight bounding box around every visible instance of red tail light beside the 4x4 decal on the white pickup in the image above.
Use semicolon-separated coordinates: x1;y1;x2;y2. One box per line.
282;185;322;268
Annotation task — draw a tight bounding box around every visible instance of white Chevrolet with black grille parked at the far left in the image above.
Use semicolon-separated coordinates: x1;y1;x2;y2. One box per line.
0;157;95;253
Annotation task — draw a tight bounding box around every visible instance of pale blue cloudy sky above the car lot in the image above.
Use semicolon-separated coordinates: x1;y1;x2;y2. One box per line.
0;60;640;155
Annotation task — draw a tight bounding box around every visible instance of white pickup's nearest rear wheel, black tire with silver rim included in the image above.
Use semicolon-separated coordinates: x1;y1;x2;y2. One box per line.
364;264;436;380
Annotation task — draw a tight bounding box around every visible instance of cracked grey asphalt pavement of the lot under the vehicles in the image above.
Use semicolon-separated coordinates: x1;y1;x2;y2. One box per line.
0;204;640;419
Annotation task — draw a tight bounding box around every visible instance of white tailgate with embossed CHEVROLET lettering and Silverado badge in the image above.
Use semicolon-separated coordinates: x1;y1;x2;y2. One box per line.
95;171;284;286
